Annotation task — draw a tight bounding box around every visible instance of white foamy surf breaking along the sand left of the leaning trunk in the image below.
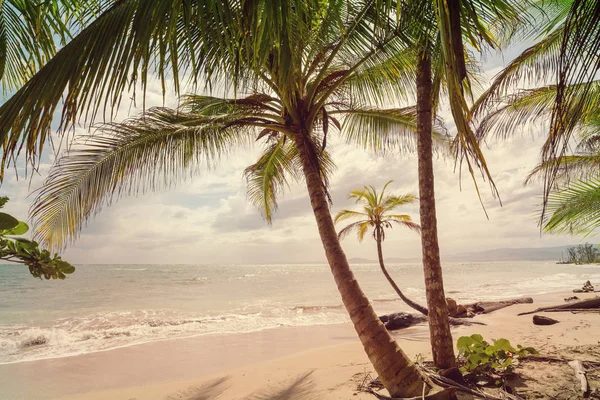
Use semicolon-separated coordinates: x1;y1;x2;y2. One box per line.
0;306;348;364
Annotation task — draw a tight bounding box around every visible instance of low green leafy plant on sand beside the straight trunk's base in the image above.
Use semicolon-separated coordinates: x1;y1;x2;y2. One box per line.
456;334;537;374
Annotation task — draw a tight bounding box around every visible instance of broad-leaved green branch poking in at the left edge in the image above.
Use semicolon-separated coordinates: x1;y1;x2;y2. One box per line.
0;197;75;279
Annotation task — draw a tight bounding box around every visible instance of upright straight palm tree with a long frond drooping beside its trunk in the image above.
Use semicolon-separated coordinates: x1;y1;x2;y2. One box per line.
390;0;527;368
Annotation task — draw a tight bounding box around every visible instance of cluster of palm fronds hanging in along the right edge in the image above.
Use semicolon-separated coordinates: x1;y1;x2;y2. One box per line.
473;0;600;236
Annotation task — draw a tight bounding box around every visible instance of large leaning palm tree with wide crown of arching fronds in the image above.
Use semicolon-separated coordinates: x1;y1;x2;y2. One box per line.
0;0;454;397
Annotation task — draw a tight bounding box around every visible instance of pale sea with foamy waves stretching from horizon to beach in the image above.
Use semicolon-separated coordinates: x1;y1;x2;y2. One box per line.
0;262;600;364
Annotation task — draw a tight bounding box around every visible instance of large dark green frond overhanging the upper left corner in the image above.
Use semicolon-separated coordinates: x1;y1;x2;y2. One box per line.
0;0;247;178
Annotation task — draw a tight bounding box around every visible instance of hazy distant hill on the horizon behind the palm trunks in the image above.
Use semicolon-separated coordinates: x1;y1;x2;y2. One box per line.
348;245;571;264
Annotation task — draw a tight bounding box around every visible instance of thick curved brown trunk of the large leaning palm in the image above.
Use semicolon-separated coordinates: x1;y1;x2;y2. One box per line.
296;133;424;397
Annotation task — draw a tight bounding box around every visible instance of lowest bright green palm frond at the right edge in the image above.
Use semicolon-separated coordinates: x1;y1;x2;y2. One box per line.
543;179;600;236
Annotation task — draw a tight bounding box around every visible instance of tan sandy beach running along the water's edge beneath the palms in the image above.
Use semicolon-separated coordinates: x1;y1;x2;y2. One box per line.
0;292;600;400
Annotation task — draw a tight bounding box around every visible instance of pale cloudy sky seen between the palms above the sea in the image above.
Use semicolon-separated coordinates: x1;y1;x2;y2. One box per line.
0;45;581;264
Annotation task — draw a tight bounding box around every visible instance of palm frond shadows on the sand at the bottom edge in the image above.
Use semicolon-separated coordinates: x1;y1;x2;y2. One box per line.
166;371;316;400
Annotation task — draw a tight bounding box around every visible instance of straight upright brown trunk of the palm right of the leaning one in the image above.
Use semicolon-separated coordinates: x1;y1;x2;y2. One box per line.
417;51;456;368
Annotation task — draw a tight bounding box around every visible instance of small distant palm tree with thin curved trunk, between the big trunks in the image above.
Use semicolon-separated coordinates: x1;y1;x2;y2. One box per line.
334;181;427;315
